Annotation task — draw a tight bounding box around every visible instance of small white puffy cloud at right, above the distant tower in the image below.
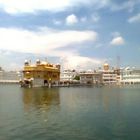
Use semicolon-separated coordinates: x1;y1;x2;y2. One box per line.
110;36;125;46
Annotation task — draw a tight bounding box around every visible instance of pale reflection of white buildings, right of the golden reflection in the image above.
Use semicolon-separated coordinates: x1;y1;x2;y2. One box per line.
60;87;123;113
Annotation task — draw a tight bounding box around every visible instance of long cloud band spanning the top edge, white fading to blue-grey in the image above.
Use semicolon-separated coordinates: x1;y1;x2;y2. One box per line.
0;0;140;14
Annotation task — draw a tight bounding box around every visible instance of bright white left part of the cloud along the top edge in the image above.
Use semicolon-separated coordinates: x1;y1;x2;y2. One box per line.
0;0;70;14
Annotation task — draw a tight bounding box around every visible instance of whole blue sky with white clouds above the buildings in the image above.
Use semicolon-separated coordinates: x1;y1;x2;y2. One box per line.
0;0;140;70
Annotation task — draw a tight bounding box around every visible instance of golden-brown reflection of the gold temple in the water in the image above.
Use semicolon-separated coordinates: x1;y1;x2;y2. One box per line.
22;87;60;110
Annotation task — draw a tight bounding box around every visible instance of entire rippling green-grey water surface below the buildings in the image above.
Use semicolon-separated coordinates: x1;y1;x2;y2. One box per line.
0;85;140;140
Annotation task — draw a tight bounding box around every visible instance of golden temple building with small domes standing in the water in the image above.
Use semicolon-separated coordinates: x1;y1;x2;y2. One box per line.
21;60;60;86
